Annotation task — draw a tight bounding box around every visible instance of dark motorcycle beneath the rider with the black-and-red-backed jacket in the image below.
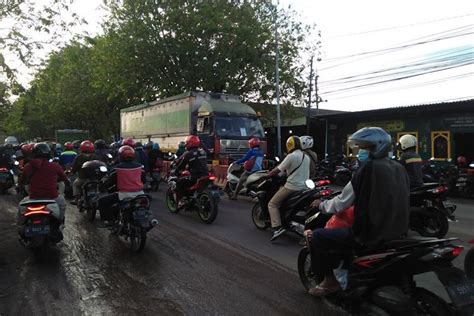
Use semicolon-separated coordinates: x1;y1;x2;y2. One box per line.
112;194;158;252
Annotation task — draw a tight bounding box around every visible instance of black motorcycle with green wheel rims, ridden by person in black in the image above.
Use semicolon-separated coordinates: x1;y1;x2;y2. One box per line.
166;160;221;224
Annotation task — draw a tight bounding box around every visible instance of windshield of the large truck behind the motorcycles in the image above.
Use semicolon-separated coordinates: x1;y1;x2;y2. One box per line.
215;116;265;137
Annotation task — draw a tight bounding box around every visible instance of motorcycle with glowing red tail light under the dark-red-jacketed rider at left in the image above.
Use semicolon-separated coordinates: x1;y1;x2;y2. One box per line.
17;199;63;251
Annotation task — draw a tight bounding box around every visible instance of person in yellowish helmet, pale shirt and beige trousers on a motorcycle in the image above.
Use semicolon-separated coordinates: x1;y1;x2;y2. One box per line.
266;136;310;241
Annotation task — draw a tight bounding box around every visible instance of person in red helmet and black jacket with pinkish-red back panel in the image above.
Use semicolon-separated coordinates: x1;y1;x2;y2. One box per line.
99;145;146;221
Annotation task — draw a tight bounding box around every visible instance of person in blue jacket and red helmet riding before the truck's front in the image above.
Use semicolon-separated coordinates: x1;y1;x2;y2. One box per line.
230;137;263;200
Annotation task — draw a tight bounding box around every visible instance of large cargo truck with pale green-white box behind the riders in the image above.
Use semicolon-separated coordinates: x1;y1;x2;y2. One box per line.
120;92;266;164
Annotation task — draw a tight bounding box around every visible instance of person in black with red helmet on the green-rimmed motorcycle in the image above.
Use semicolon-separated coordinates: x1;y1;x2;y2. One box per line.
175;135;209;208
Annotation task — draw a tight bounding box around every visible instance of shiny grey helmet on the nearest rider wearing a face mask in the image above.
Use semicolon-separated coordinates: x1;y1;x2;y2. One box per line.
347;127;392;159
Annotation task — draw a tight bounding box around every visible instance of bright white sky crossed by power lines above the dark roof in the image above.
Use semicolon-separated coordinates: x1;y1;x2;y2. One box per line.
1;0;474;111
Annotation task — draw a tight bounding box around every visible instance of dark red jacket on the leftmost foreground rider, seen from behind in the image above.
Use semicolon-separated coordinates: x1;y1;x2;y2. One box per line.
19;159;67;199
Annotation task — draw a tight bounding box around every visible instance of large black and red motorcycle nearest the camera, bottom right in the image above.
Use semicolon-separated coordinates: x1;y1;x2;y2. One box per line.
298;212;474;315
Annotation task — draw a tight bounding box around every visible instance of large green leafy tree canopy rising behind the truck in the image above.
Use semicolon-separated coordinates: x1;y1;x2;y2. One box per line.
8;0;310;137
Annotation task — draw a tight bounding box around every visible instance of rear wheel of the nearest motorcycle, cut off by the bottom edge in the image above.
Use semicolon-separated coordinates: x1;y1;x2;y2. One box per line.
412;287;453;316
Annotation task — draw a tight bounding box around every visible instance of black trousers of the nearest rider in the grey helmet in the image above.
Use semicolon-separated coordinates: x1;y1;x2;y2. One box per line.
311;227;356;279
